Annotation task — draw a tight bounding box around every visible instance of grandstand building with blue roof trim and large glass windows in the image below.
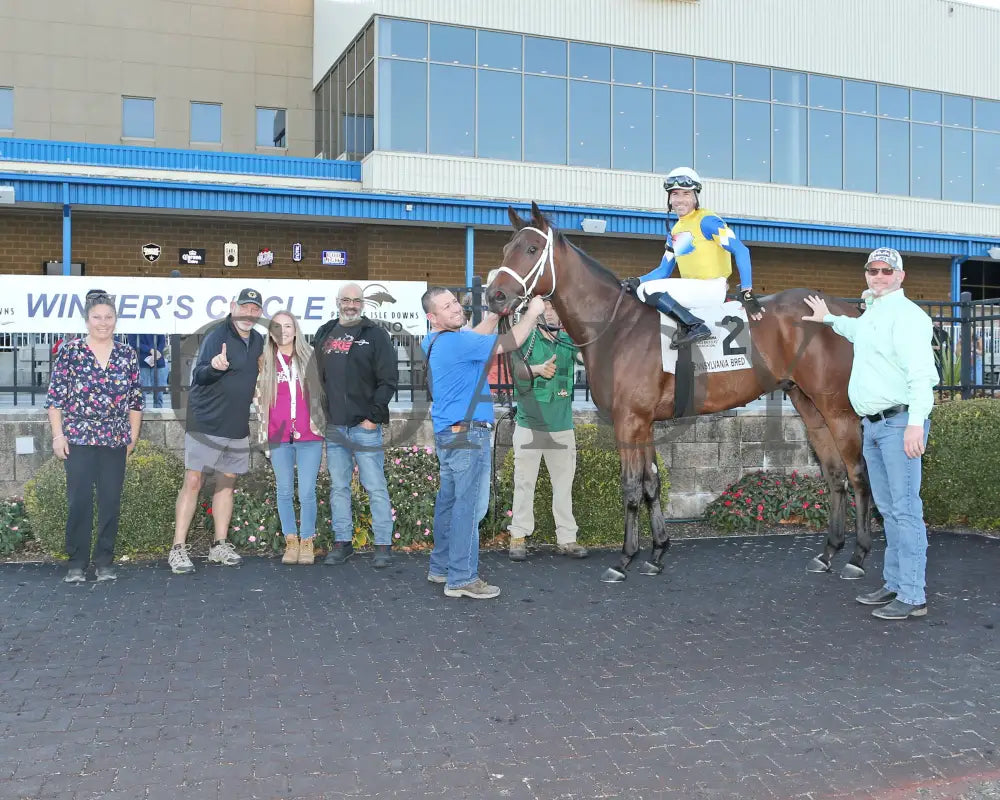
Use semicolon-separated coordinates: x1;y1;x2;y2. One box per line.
0;0;1000;299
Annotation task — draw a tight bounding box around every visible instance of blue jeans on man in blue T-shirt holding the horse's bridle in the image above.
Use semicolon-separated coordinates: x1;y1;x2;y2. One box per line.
430;428;491;589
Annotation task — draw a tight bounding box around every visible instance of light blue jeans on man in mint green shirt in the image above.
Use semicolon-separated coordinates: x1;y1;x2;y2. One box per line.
861;413;931;605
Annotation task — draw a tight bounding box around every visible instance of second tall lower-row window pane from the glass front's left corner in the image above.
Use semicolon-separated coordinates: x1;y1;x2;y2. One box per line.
427;64;476;157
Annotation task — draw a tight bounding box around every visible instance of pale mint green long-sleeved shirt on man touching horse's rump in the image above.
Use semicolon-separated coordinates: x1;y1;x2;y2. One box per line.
823;289;938;425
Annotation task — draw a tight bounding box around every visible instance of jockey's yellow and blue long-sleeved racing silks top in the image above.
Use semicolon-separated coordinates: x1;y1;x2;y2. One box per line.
639;208;753;289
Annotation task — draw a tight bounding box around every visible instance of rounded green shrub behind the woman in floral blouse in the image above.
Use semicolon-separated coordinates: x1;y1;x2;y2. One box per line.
24;439;184;556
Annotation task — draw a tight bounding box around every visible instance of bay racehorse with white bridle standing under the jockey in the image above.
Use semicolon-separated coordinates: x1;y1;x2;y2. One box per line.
486;203;872;583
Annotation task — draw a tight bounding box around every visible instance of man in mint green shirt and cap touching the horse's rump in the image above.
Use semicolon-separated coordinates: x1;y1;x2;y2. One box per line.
802;247;938;619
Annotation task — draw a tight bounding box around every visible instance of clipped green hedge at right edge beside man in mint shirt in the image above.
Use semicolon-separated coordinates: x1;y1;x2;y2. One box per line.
920;399;1000;530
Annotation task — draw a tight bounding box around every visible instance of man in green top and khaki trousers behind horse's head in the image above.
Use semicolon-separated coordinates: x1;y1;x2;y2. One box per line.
510;300;587;561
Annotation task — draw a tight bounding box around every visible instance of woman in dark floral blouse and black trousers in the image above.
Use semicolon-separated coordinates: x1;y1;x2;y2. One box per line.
45;290;143;583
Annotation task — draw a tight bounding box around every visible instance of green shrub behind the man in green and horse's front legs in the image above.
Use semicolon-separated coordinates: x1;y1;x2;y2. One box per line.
482;425;670;546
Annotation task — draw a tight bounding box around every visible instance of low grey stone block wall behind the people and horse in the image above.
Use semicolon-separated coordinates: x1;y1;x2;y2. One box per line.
0;403;819;518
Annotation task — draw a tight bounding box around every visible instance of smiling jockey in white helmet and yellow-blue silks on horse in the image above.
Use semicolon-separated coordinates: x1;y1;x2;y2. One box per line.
622;167;764;349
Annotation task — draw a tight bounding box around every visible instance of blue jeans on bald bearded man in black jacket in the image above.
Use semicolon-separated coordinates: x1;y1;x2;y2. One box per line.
326;425;392;545
